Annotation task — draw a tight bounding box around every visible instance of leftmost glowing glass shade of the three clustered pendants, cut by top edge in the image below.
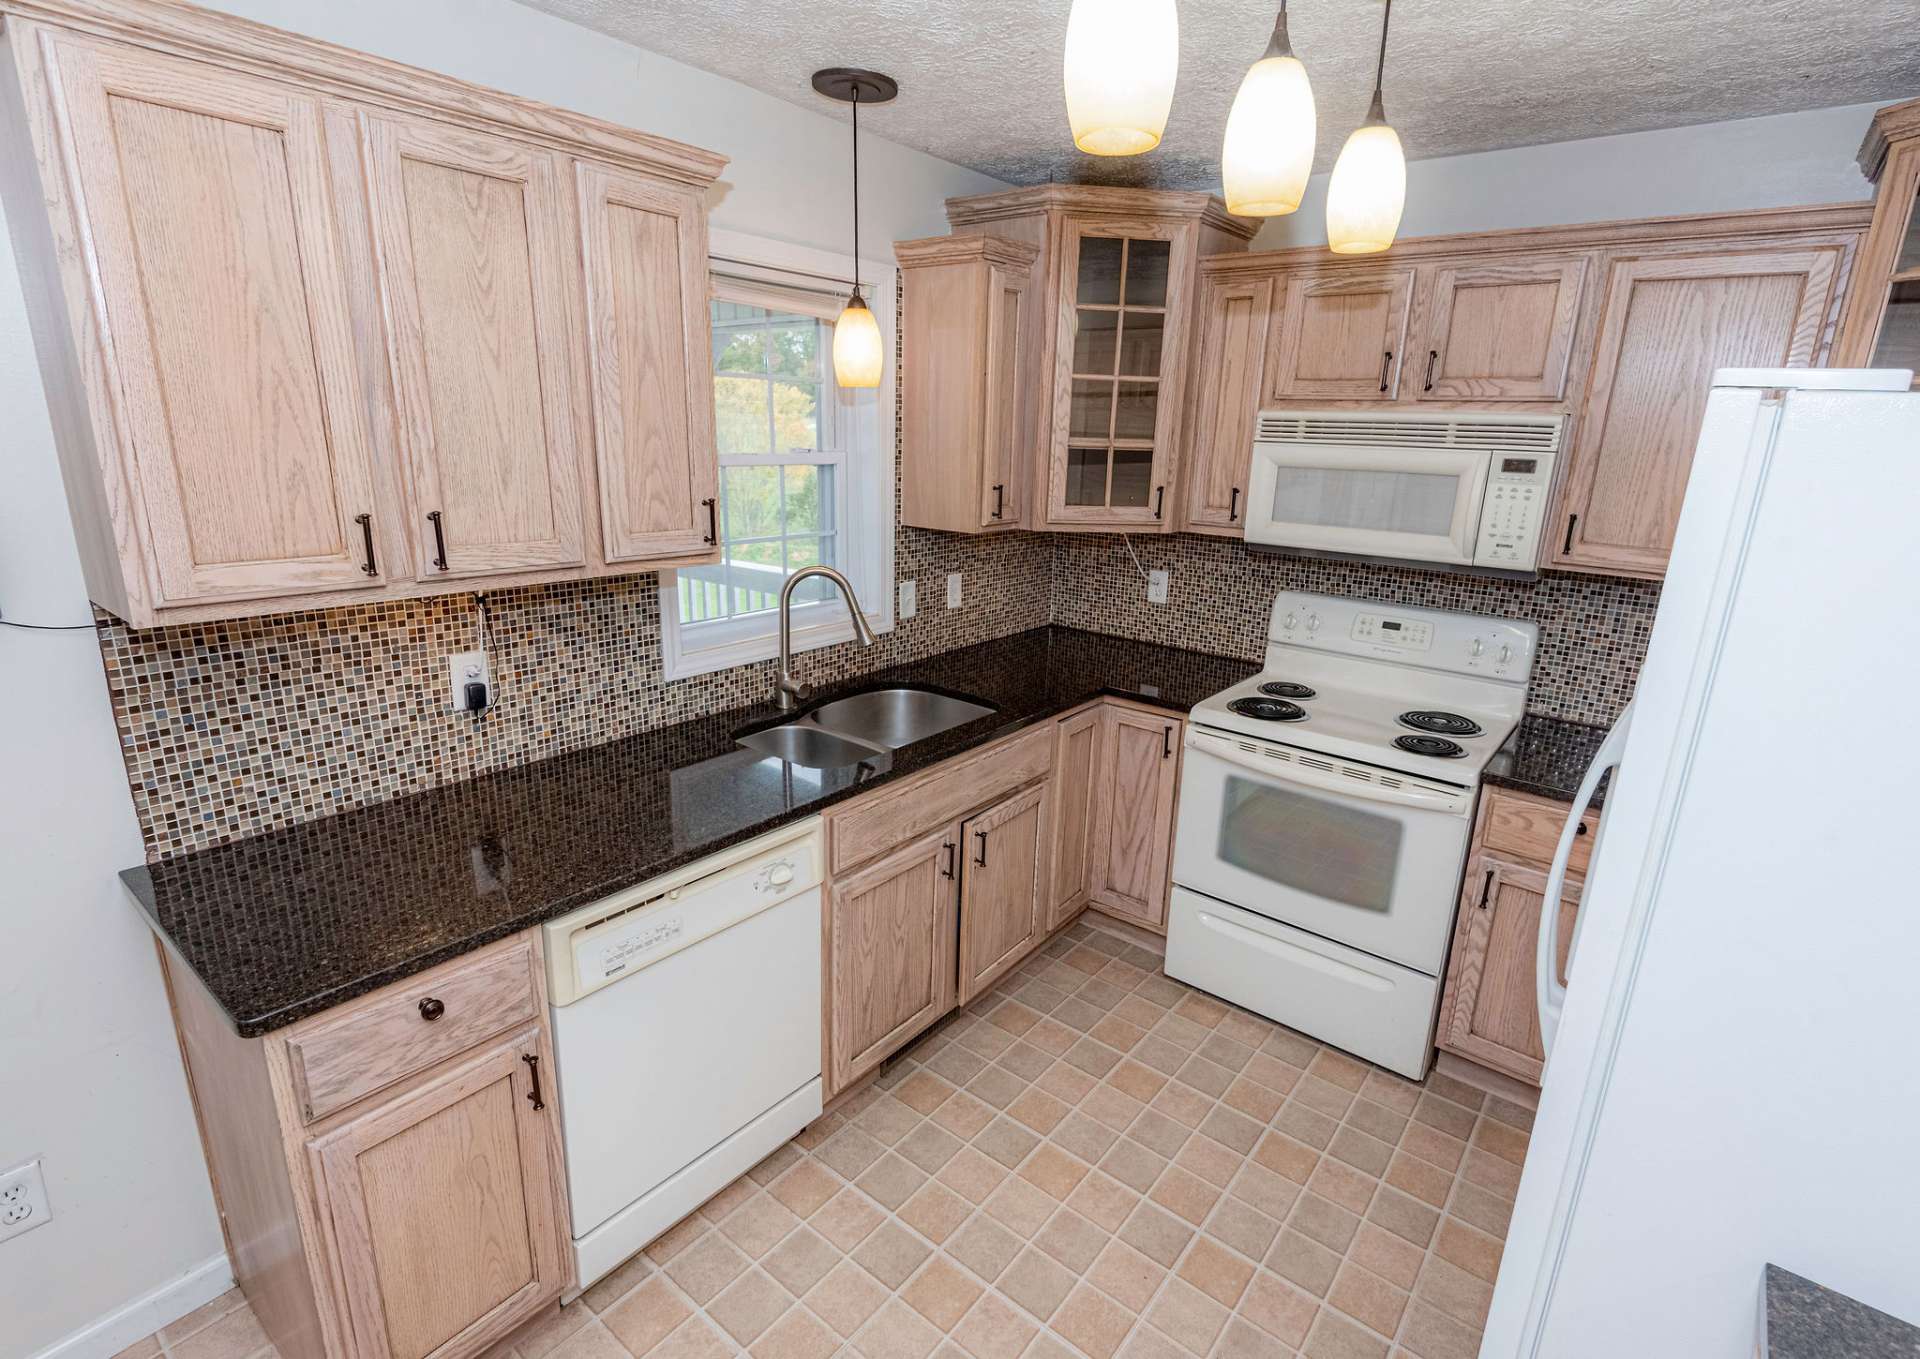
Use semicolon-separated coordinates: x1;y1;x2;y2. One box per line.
1064;0;1181;155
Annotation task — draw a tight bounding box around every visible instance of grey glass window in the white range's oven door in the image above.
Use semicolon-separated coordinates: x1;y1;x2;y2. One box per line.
1219;774;1405;914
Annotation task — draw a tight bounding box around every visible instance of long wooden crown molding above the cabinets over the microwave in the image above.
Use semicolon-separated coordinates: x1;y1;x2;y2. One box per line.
1200;200;1874;278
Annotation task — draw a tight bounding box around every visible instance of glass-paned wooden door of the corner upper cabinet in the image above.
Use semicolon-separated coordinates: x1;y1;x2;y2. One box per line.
1046;219;1196;530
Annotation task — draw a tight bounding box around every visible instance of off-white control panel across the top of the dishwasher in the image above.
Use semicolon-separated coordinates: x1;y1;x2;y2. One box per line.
543;822;822;1006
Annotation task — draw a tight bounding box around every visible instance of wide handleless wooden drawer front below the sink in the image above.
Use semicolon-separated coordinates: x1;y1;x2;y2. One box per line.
828;722;1054;873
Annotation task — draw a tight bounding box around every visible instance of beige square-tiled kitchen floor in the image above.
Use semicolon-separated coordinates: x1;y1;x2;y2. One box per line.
116;921;1532;1359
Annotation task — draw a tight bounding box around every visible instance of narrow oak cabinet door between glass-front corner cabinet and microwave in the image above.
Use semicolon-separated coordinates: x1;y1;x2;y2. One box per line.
1185;278;1273;536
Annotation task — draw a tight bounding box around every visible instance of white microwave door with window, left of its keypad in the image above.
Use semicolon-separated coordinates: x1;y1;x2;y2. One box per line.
1246;441;1492;564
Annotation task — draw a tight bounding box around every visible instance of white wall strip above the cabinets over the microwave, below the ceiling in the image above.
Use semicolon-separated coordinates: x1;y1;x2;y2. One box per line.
1254;104;1880;250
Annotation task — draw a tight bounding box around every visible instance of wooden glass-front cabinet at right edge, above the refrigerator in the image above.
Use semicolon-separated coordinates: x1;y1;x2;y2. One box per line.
1832;100;1920;388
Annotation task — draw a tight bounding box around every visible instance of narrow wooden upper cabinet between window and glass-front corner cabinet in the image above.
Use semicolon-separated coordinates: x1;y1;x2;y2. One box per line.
895;236;1039;534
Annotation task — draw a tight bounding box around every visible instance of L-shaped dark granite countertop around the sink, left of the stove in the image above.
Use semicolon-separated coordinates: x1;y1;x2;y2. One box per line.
121;628;1260;1038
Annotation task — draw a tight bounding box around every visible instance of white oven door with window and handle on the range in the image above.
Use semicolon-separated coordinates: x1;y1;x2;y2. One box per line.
1173;727;1473;975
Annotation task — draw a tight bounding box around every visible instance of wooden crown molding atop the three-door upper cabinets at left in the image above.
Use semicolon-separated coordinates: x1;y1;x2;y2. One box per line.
0;0;728;188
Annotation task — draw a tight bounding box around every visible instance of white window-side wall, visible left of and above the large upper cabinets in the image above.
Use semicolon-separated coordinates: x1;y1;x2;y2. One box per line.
0;0;1000;1359
